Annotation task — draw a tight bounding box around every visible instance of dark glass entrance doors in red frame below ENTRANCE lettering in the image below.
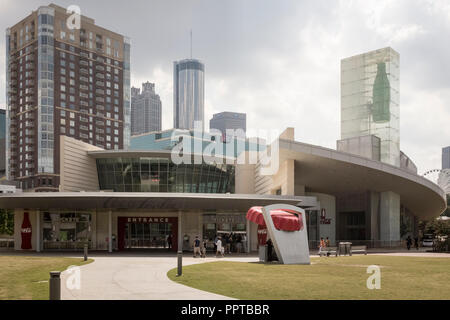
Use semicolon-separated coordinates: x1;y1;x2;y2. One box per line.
125;222;172;249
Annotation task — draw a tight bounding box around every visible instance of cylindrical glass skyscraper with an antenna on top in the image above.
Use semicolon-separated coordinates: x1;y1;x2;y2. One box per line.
173;59;205;130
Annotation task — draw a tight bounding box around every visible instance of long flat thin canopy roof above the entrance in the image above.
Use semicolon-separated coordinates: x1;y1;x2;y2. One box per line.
0;192;317;212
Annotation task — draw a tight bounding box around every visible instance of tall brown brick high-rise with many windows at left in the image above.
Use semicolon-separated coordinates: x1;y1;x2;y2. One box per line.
6;4;131;191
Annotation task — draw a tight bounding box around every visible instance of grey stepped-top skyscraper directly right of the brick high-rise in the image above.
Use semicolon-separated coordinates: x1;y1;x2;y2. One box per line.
131;82;162;135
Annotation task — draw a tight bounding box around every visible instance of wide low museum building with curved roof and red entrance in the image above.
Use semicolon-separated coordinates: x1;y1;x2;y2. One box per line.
0;128;446;252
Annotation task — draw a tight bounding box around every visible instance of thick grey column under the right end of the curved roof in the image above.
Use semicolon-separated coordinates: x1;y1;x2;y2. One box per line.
380;191;400;241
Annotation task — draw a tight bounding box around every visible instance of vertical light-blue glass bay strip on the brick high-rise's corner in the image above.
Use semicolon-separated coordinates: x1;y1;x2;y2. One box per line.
36;8;55;173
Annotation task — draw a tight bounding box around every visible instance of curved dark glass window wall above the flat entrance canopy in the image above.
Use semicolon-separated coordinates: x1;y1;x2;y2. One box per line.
97;157;235;193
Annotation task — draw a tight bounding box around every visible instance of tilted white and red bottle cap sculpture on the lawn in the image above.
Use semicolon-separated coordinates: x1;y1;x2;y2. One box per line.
247;204;311;265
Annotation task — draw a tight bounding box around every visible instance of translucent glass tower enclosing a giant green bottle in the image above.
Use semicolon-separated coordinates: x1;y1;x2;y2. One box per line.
341;48;400;166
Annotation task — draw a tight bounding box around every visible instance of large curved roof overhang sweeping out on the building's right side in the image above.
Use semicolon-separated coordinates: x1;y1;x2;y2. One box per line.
280;140;447;219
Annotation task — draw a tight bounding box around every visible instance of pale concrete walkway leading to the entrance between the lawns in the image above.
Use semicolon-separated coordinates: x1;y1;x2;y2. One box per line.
61;256;258;300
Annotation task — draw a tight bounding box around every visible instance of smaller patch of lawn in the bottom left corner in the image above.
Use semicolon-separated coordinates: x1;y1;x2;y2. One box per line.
0;256;93;300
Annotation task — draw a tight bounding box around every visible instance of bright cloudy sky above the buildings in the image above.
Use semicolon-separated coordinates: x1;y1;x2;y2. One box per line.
0;0;450;174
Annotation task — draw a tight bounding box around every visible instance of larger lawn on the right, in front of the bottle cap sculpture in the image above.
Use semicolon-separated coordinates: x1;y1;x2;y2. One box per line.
168;255;450;300
